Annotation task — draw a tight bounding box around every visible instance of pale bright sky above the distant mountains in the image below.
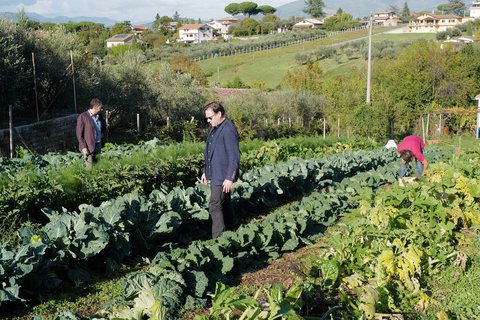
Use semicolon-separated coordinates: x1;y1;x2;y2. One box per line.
0;0;294;23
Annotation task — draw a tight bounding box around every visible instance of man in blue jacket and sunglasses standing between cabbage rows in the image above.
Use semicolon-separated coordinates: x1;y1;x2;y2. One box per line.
201;101;240;238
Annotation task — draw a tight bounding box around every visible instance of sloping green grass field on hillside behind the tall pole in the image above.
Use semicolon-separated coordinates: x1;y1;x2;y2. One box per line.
198;28;435;89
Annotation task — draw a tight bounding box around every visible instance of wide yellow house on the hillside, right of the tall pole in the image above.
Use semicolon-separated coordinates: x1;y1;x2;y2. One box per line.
407;14;463;33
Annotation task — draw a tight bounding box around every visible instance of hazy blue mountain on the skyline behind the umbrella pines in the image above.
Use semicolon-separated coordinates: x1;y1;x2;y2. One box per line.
275;0;446;19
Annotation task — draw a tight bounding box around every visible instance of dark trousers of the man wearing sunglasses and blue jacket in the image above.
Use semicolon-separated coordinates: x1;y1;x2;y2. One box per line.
208;184;236;239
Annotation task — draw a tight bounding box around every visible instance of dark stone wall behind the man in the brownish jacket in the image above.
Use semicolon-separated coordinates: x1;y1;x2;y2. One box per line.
0;114;78;156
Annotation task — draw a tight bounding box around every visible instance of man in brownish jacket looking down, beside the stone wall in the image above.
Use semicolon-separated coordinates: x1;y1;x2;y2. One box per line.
77;98;106;169
